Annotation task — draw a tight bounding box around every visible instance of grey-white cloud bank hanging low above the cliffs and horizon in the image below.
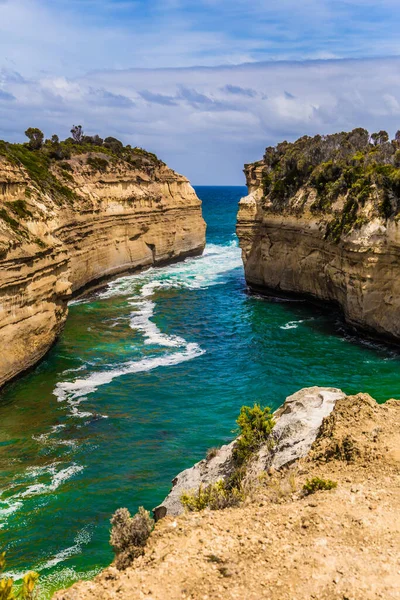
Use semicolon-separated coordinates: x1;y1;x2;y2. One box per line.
0;58;400;185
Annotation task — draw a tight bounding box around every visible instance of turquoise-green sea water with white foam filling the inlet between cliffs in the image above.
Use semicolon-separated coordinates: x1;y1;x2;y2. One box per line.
0;187;400;598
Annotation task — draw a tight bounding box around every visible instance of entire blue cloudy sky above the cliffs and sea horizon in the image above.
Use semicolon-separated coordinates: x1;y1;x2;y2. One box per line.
0;0;400;185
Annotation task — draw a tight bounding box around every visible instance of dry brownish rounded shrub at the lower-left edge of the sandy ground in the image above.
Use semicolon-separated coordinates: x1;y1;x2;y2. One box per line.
110;506;154;570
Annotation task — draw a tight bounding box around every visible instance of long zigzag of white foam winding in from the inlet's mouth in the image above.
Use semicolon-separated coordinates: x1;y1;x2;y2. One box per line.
53;240;241;404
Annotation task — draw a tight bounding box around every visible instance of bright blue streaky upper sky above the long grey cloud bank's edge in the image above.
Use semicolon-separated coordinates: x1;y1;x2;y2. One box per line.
0;0;400;77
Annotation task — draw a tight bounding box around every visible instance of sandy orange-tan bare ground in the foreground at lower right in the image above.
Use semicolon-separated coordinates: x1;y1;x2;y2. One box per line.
55;394;400;600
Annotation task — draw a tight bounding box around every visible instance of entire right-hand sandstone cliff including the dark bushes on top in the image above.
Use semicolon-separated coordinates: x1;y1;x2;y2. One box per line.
237;130;400;341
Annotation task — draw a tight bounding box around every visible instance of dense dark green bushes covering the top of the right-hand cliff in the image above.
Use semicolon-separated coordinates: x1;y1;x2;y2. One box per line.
255;128;400;242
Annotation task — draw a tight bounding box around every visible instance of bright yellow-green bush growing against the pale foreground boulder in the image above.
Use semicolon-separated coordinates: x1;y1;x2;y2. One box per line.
233;404;275;465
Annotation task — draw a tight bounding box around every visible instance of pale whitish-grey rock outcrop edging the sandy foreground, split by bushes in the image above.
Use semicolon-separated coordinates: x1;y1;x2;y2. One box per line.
153;387;345;520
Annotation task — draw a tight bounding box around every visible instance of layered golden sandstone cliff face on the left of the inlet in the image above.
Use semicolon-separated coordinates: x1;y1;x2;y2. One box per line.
0;148;205;385
